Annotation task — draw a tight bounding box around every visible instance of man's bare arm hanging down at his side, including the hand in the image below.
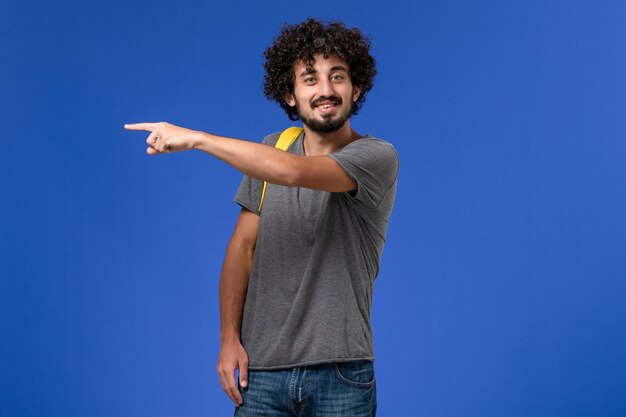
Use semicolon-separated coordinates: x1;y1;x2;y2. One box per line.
217;209;260;406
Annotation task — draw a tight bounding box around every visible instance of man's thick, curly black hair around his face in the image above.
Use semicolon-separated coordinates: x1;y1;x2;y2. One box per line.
263;18;376;120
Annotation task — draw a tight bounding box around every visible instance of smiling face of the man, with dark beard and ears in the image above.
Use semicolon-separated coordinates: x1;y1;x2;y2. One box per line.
285;54;360;133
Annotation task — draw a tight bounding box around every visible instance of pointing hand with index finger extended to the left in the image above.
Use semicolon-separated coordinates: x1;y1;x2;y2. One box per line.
124;122;201;155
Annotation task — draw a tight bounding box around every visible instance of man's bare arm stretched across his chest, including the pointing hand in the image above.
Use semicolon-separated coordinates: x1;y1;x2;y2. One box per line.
124;122;357;192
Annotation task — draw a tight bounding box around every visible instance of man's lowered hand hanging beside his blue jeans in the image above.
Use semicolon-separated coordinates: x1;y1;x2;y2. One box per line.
217;340;248;407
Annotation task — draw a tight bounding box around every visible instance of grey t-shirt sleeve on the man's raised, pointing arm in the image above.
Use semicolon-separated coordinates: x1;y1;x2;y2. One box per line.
328;136;399;207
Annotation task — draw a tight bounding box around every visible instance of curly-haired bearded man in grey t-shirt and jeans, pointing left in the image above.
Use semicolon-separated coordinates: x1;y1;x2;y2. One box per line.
126;19;398;417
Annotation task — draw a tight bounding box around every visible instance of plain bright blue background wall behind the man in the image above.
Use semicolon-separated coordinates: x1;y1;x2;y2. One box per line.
0;0;626;417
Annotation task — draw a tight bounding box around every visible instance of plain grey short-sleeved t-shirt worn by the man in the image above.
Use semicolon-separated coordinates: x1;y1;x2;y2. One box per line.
235;129;398;369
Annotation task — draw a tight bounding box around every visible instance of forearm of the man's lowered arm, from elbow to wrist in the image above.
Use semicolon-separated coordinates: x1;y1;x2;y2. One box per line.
220;237;254;341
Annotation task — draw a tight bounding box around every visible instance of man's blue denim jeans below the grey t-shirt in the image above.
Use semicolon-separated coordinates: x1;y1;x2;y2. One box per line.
235;360;376;417
